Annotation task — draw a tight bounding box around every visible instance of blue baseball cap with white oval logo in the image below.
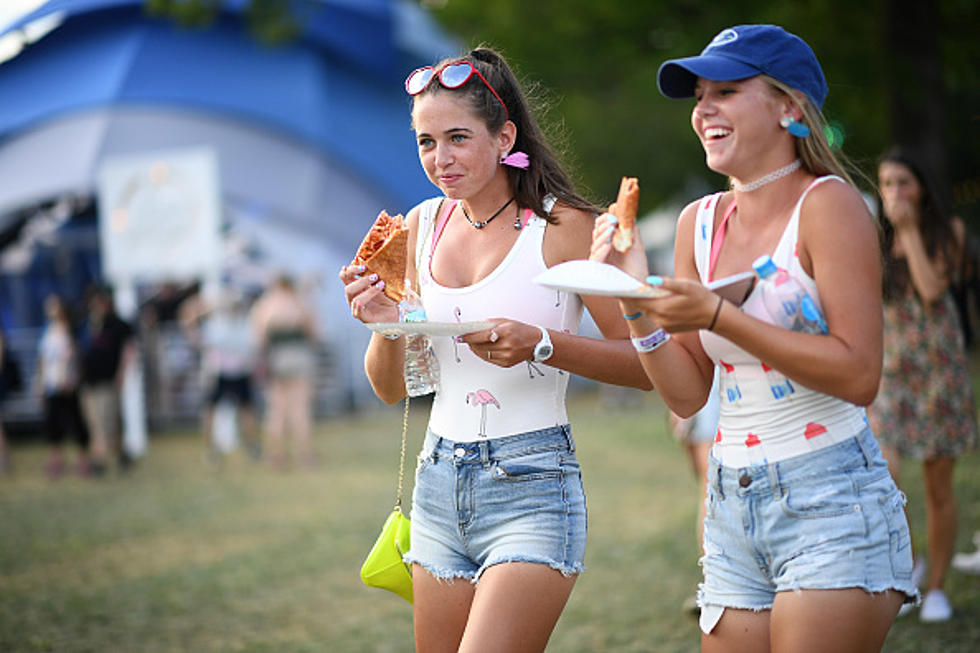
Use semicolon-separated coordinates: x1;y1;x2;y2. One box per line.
657;25;827;109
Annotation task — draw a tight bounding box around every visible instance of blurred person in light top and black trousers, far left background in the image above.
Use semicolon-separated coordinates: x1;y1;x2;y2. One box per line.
35;295;90;479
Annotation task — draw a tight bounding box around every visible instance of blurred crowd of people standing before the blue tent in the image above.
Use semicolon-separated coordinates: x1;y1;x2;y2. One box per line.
0;275;319;480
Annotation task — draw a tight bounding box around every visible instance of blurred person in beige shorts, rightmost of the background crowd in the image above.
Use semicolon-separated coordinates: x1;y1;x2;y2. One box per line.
251;274;316;469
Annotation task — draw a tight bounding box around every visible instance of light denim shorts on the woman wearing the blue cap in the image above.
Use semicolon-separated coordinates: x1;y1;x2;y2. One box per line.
698;428;918;633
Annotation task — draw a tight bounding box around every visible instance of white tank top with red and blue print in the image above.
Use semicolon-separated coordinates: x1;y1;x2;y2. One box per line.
694;176;867;467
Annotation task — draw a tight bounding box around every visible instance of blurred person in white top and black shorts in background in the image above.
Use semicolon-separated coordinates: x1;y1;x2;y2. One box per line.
180;288;262;466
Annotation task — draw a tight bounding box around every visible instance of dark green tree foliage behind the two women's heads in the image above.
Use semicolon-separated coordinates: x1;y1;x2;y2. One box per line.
428;0;980;218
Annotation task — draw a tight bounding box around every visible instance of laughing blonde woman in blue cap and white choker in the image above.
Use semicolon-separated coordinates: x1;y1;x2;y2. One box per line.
592;25;917;652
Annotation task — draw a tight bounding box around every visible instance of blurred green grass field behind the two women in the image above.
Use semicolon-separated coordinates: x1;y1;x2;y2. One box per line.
0;384;980;653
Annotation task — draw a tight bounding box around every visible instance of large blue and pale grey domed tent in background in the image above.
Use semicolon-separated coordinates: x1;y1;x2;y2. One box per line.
0;0;459;416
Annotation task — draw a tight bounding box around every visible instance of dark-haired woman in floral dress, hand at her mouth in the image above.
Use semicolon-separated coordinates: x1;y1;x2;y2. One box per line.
868;147;977;621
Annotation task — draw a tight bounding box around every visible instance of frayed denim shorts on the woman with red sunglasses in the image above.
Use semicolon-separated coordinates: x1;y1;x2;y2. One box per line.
405;425;587;583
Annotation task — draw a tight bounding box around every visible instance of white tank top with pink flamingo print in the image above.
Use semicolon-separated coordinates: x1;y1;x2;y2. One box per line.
416;198;582;442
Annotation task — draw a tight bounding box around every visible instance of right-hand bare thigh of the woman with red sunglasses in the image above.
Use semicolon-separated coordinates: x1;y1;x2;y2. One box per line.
459;562;576;653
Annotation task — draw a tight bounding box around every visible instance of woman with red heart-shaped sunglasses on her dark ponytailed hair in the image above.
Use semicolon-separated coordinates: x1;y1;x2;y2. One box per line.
340;48;651;651
